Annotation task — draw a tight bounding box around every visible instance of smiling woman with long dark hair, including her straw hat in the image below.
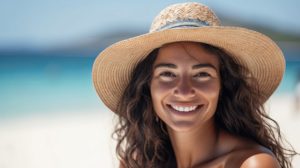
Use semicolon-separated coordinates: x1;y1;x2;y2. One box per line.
93;2;295;168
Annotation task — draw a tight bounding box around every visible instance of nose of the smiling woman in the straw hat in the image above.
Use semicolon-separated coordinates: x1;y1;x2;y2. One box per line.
173;78;196;99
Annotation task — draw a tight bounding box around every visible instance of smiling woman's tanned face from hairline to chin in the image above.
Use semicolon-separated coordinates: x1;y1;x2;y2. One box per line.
150;42;221;131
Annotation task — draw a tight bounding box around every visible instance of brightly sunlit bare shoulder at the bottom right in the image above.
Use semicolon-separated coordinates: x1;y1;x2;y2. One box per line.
241;153;280;168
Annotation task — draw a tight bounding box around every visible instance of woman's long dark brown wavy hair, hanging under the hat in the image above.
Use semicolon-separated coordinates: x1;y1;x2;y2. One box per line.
113;43;297;168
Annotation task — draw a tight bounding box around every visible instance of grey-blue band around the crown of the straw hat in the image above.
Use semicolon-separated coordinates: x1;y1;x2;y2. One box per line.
151;19;210;32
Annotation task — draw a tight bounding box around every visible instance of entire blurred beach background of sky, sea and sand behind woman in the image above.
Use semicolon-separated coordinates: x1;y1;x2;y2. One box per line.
0;0;300;168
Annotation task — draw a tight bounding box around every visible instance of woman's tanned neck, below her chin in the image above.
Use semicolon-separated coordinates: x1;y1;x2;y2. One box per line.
168;123;219;168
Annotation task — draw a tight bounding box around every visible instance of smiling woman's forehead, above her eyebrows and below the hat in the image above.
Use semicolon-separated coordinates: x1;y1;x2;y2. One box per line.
155;42;219;67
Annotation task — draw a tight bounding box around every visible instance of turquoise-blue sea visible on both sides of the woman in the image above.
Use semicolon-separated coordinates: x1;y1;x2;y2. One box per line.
0;51;300;118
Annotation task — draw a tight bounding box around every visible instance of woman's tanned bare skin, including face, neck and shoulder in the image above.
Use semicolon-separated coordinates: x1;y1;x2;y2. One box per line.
120;42;280;168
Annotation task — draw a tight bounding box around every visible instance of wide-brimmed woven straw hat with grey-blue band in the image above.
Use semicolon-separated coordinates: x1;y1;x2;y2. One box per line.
92;2;285;111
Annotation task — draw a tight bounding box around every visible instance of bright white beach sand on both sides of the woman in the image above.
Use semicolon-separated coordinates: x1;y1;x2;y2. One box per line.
0;96;300;168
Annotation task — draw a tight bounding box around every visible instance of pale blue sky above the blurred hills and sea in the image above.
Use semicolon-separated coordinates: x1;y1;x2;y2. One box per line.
0;0;300;48
